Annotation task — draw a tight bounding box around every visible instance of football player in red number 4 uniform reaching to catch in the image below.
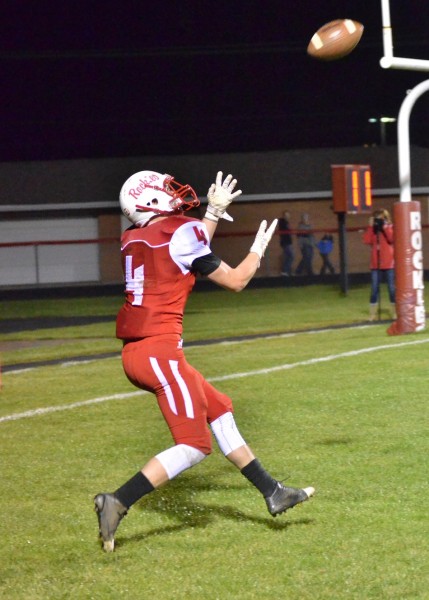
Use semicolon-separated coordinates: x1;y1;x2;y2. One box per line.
94;171;314;552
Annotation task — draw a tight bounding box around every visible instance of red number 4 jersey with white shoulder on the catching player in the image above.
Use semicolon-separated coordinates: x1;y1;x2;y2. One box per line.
116;215;211;340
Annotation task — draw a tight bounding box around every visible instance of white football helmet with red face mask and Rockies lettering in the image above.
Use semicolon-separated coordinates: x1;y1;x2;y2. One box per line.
119;171;200;227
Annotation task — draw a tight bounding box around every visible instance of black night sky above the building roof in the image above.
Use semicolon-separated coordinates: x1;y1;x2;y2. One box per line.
0;0;429;161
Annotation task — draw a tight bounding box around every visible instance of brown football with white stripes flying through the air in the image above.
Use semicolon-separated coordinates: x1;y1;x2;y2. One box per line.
307;19;363;60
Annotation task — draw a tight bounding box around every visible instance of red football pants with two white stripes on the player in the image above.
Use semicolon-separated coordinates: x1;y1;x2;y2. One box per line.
122;335;233;454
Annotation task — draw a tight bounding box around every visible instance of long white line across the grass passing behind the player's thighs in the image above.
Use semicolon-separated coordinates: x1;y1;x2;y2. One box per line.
0;338;429;423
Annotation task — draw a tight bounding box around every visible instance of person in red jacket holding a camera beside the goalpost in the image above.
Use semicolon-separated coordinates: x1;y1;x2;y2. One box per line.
363;209;396;321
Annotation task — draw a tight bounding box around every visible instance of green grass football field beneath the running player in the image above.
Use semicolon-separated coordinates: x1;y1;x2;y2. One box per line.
0;286;429;600
